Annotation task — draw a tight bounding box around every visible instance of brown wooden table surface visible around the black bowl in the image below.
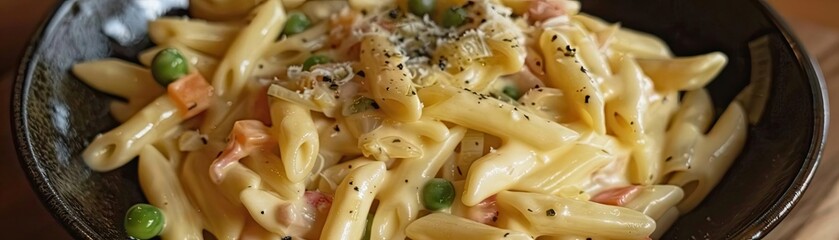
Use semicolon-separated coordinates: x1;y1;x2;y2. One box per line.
0;0;839;239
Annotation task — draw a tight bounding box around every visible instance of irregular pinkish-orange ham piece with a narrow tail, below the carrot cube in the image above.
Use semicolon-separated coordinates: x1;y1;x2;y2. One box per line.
210;120;277;183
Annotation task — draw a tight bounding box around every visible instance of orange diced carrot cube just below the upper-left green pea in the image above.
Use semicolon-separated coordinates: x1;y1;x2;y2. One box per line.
167;72;213;118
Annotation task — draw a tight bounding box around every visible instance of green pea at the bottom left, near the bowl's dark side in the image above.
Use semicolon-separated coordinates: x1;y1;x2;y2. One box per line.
125;203;165;239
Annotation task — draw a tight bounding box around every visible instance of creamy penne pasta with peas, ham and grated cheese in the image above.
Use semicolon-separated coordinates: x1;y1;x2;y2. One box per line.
72;0;748;240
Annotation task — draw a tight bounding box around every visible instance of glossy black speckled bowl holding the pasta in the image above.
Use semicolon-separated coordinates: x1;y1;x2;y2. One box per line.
12;0;828;239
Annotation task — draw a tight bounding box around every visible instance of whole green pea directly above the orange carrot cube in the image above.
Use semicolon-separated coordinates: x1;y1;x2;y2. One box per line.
151;48;189;86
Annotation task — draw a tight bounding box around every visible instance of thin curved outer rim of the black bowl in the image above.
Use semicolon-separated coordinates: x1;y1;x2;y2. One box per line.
10;0;830;239
